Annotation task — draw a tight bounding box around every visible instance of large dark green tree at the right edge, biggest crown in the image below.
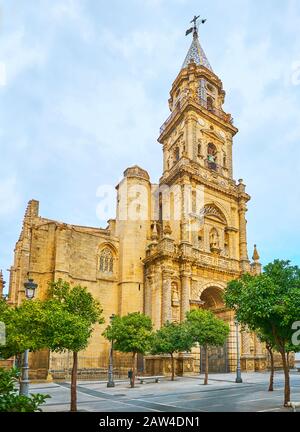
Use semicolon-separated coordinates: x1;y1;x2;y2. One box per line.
225;260;300;406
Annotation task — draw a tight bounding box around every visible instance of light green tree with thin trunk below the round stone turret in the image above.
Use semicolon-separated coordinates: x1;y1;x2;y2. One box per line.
103;312;153;387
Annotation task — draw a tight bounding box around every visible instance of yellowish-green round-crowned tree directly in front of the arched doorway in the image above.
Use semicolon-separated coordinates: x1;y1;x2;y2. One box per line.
186;309;229;385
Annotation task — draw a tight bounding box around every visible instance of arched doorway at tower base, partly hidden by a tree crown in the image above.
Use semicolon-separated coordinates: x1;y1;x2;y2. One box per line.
193;286;229;373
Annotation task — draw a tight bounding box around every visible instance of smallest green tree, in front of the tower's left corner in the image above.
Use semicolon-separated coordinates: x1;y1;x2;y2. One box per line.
151;322;194;381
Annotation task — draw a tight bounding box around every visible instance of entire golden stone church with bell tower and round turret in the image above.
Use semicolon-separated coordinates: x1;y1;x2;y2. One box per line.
5;26;267;377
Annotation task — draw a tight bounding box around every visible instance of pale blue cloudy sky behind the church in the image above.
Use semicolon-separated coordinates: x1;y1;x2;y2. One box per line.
0;0;300;290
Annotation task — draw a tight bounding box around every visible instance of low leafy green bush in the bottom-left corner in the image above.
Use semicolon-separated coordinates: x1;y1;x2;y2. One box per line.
0;368;50;412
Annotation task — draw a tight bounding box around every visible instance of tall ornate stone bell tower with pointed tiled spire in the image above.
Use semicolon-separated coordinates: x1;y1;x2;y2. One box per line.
144;17;265;372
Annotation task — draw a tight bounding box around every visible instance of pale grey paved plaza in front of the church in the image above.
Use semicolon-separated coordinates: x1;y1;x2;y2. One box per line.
30;371;300;412
